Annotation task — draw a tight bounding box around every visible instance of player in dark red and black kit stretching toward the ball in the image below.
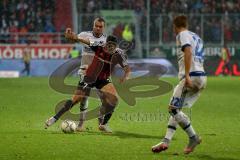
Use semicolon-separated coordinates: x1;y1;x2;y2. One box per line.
45;29;130;133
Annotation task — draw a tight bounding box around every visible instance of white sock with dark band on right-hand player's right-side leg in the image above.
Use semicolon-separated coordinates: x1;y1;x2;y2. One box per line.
174;111;196;138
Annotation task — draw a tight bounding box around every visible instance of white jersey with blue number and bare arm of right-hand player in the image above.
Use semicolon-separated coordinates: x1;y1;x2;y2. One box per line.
176;30;204;79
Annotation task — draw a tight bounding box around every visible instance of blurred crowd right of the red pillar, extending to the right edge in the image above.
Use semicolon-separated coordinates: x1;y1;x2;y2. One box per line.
82;0;240;43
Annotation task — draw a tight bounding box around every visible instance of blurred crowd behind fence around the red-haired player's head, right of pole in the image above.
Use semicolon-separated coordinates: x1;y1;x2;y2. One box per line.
151;0;240;43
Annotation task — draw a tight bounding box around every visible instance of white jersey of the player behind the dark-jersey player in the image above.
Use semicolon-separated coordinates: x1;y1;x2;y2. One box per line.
78;31;107;68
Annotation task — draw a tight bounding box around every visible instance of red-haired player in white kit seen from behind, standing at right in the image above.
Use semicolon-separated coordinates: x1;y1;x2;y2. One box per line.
152;15;206;154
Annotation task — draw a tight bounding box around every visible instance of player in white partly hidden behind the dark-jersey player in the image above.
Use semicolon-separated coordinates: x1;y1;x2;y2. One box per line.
77;17;107;131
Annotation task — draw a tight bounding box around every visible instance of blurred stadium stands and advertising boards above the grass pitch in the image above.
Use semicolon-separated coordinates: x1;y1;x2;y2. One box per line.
0;0;240;76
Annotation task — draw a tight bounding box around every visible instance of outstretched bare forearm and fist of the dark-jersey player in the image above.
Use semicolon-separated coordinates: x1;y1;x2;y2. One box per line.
64;28;90;45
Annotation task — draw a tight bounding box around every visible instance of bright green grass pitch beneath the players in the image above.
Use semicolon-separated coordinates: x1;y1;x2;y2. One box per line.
0;77;240;160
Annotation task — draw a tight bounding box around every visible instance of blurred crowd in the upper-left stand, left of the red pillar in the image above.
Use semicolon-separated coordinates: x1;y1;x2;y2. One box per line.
0;0;55;33
